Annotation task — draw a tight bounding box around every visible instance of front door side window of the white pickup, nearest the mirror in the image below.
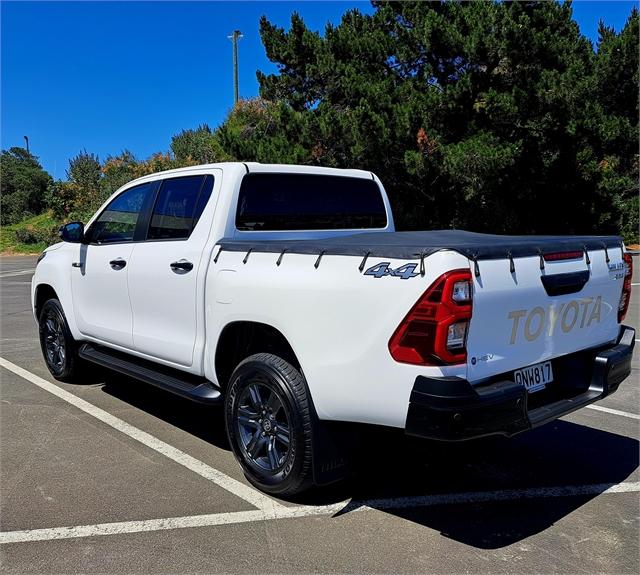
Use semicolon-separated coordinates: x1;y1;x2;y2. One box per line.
91;182;154;244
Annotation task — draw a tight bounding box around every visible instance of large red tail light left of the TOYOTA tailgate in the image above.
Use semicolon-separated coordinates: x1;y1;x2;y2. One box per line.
389;269;472;365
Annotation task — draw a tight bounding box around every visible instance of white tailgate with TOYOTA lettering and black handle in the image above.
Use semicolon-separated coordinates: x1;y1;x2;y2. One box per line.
467;249;623;382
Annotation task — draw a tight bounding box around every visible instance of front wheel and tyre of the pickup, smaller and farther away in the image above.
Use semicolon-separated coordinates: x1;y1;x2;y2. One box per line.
38;299;80;383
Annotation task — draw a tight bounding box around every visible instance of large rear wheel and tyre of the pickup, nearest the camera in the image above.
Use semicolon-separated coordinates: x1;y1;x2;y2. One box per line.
225;353;313;496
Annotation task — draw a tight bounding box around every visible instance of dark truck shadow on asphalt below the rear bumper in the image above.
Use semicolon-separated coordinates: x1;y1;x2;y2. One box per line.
328;420;640;549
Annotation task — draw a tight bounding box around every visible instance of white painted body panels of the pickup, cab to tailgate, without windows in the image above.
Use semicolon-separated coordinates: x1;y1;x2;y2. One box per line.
32;163;622;427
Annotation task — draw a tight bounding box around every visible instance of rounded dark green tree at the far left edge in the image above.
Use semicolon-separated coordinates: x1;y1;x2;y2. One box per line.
0;148;51;225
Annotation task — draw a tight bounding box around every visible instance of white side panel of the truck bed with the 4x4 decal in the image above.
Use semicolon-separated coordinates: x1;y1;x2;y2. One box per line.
206;251;469;427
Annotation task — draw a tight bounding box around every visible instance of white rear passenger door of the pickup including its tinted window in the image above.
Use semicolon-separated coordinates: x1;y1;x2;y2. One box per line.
128;174;214;367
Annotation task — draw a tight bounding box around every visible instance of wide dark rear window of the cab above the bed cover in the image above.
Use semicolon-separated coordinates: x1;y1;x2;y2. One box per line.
236;173;387;231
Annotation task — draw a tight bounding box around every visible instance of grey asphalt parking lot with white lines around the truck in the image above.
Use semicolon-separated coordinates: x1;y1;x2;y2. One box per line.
0;257;640;574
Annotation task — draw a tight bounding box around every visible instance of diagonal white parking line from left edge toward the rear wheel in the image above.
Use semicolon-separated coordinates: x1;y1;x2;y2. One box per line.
0;357;286;516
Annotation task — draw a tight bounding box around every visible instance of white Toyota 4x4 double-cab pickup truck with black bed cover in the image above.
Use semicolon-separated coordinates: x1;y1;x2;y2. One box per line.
32;163;635;495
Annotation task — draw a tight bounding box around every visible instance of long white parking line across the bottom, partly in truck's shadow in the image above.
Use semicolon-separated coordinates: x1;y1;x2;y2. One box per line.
0;481;640;543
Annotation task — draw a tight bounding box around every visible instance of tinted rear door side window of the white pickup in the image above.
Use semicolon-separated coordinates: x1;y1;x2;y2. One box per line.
147;176;213;240
